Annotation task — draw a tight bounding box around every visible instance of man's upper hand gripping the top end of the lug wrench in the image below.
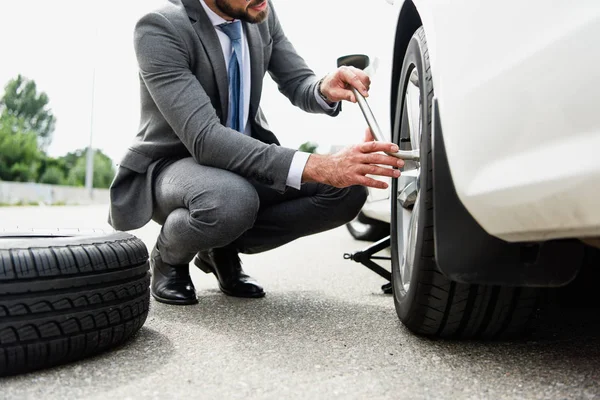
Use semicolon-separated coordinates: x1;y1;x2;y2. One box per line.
321;67;371;103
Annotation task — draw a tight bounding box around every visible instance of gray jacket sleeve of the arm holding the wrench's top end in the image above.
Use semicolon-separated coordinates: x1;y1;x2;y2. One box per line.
269;2;341;116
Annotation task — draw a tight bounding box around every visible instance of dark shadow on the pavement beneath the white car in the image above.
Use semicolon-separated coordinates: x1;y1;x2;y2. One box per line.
421;306;600;388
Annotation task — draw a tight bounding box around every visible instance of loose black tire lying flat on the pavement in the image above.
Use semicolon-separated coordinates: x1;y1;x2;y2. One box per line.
0;232;150;376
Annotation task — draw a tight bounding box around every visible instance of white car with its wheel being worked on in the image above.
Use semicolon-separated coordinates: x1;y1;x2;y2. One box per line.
349;0;600;338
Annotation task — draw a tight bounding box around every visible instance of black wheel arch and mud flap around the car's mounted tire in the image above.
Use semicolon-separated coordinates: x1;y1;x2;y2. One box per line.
390;11;583;287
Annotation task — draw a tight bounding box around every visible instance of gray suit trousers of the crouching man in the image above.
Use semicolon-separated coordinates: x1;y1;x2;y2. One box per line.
152;158;367;265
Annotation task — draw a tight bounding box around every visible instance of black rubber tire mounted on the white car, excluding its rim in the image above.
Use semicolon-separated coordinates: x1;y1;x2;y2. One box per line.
392;27;540;339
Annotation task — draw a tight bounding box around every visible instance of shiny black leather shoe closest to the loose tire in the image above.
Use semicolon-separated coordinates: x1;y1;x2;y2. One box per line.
150;246;198;305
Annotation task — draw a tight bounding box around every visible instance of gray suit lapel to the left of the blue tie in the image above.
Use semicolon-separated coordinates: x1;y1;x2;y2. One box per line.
182;0;229;124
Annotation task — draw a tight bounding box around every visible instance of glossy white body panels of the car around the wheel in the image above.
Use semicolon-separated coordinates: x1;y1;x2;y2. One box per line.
358;0;600;241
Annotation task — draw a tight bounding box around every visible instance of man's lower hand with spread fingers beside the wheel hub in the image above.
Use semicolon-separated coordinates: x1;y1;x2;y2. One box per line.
302;129;404;189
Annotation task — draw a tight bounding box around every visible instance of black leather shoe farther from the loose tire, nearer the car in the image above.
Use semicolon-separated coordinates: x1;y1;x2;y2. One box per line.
194;248;265;298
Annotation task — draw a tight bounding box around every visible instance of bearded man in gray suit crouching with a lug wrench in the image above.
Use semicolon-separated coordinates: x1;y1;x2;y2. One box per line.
109;0;403;304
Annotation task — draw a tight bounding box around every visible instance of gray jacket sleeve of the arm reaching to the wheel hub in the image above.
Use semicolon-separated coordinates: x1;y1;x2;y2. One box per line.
134;13;295;191
